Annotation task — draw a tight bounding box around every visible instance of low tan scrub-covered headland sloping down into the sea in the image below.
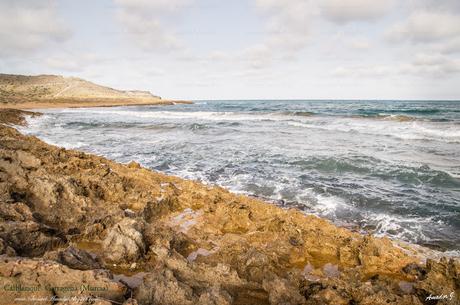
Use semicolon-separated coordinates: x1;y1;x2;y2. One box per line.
0;74;187;108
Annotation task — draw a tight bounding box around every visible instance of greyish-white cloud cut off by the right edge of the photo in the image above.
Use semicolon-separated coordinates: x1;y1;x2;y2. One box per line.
387;11;460;43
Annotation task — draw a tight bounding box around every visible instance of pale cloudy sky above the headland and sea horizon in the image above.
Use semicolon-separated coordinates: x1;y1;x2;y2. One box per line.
0;0;460;100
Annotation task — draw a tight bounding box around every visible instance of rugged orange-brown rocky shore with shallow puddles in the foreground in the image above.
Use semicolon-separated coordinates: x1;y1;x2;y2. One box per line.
0;110;460;305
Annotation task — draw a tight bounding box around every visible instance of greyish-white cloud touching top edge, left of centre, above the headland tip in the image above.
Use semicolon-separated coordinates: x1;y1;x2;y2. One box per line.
114;0;191;51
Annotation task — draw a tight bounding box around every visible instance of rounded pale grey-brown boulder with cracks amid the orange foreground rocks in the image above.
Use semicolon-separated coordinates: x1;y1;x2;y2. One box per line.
103;218;145;263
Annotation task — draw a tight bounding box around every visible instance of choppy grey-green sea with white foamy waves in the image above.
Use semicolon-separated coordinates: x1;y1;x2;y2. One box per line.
23;100;460;250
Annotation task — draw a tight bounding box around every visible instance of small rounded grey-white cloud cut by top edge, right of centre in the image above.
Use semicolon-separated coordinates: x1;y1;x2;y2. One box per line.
318;0;393;24
